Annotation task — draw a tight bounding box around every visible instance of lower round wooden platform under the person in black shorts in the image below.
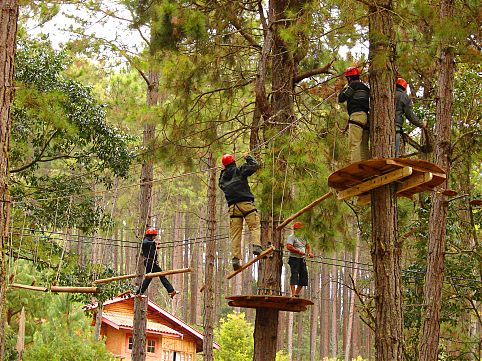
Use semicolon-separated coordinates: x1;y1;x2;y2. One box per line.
226;295;313;312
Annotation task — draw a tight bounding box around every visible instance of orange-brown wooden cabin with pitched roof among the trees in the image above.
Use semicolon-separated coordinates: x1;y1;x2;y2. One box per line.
85;295;219;361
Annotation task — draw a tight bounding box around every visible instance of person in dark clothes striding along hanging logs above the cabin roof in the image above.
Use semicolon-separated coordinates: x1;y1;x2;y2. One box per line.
136;228;179;298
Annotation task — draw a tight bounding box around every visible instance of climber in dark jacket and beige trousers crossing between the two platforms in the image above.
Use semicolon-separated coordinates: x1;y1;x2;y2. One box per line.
219;153;263;271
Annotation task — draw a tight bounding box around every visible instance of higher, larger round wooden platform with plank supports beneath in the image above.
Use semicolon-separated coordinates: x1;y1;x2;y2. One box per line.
328;158;446;204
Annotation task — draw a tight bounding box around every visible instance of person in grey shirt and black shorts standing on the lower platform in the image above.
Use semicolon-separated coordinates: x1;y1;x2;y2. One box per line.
286;222;313;297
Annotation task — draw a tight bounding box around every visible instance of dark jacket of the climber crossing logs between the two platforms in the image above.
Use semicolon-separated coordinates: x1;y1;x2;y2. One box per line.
219;155;259;205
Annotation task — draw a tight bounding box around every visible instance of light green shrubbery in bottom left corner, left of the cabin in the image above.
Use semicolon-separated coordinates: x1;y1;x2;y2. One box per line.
6;260;123;360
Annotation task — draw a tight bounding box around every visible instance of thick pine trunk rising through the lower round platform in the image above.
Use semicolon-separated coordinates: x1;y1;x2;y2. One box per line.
251;0;305;361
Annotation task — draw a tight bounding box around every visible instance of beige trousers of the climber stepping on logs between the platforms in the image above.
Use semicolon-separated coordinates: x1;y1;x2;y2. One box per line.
229;202;261;259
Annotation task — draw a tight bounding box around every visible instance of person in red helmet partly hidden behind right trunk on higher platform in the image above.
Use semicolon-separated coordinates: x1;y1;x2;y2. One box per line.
395;78;427;157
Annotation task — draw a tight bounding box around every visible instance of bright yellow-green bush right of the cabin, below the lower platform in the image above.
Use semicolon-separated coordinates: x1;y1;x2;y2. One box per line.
214;313;254;361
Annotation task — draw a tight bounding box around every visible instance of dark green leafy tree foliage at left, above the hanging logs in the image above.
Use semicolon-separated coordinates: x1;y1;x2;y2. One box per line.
10;39;134;231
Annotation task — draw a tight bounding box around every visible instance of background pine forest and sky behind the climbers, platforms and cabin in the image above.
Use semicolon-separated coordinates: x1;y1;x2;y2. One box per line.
0;0;482;361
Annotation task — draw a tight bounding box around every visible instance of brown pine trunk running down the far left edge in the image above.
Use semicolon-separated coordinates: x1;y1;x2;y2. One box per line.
0;0;18;360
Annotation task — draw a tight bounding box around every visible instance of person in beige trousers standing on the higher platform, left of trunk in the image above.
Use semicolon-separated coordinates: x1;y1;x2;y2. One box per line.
338;66;370;162
